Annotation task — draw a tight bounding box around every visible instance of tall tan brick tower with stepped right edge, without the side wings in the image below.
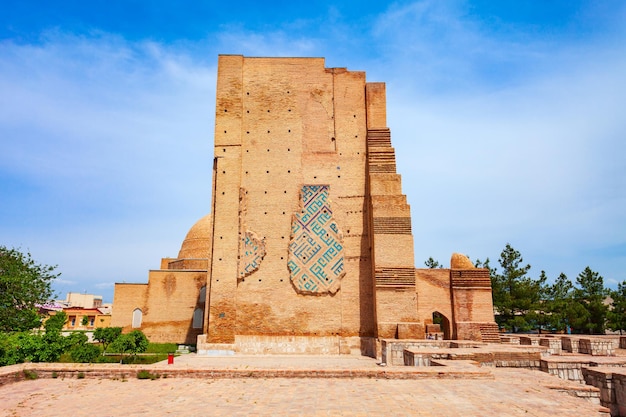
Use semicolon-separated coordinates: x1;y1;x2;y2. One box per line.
200;56;417;352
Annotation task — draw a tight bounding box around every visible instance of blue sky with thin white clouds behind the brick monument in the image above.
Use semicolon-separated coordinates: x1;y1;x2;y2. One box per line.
0;0;626;301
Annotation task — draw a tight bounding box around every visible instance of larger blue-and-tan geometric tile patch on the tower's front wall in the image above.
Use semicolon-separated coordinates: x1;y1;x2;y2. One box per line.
287;185;345;295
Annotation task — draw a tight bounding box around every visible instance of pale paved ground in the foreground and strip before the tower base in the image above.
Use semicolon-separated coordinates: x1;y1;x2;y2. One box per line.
0;356;601;417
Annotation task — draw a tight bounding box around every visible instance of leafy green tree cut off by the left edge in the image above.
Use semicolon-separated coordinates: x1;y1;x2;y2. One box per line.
0;246;60;332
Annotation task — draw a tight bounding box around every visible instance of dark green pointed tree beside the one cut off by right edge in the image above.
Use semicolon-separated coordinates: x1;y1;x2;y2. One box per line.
574;266;608;334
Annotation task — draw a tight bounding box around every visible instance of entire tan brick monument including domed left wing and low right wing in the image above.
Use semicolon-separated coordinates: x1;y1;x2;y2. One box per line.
111;55;499;354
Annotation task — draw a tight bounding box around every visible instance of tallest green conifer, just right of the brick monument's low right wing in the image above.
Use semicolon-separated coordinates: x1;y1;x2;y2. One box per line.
490;243;546;332
